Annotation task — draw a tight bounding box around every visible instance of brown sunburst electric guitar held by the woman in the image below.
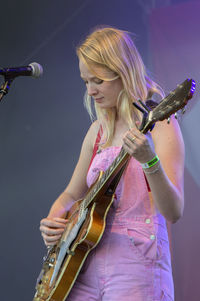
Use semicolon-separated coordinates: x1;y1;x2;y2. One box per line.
33;79;195;301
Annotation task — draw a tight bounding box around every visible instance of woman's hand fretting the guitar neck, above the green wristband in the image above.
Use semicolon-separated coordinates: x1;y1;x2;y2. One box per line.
123;128;156;163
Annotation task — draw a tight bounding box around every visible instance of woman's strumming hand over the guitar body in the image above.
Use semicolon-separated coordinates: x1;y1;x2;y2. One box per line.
40;217;67;246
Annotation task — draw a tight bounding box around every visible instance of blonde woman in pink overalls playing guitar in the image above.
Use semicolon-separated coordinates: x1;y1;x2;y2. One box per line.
40;28;184;301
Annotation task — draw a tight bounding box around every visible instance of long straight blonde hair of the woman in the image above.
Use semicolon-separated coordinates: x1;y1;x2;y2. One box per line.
77;27;164;147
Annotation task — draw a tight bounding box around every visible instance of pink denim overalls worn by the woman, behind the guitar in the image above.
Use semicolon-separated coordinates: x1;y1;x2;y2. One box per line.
67;146;174;301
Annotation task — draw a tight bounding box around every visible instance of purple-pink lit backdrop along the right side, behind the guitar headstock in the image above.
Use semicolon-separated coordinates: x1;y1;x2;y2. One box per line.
149;1;200;301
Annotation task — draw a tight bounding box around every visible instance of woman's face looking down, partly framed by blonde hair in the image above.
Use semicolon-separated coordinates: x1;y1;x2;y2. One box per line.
79;60;123;108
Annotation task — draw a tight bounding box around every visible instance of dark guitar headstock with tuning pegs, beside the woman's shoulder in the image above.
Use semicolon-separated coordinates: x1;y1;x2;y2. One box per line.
142;79;195;133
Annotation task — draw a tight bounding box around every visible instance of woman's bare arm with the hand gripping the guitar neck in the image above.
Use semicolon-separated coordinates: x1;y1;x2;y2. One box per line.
124;118;184;222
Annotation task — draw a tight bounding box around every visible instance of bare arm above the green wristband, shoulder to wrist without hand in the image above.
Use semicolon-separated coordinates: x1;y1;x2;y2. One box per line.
146;119;185;222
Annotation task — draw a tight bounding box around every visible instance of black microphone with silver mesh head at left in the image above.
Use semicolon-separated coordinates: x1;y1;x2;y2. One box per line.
0;63;43;79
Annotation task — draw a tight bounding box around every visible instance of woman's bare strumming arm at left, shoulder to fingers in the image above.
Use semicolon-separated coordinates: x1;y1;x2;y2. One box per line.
40;122;98;245
